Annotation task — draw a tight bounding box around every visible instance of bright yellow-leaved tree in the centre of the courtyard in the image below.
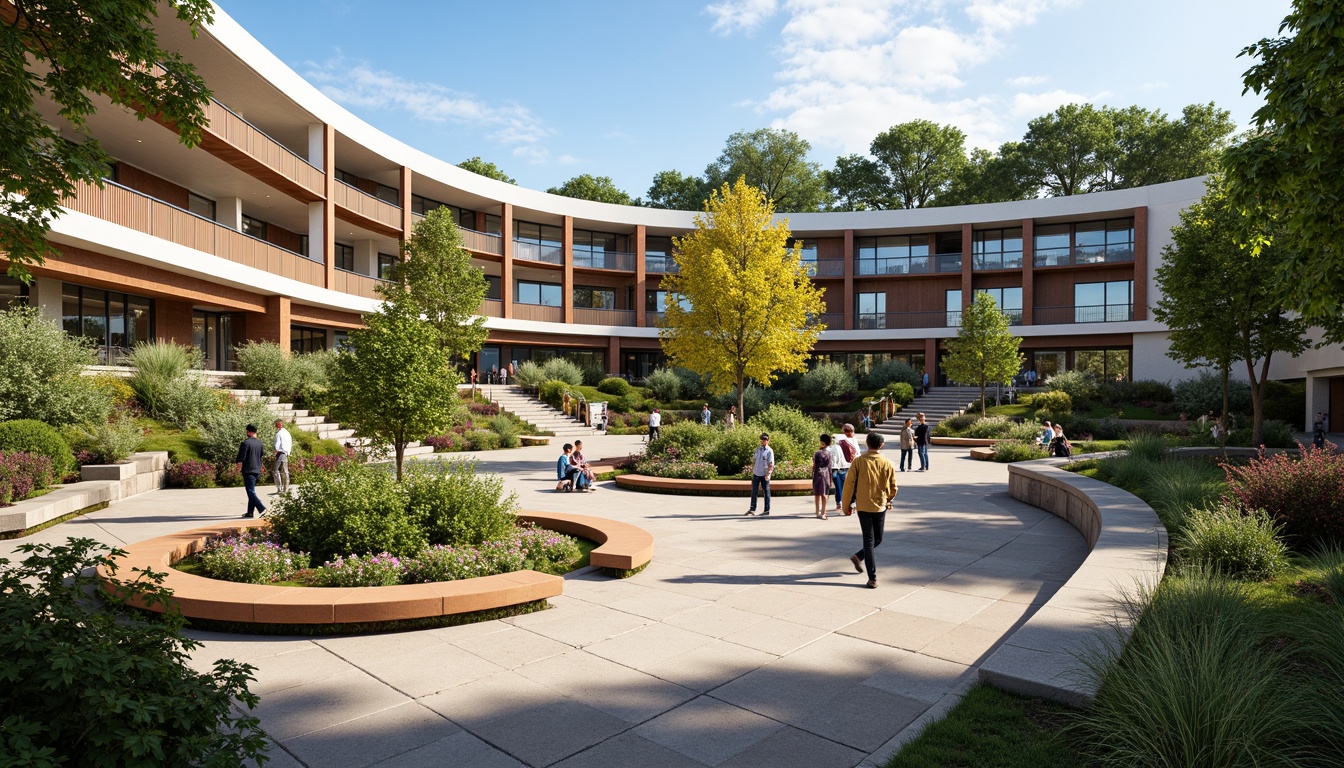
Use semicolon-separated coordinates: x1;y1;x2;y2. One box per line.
659;178;825;418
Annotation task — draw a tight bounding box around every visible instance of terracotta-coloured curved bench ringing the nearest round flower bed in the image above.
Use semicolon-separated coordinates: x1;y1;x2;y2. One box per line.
99;512;653;624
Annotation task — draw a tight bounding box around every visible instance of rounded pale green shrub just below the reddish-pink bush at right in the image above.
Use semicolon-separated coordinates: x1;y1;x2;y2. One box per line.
1173;504;1288;581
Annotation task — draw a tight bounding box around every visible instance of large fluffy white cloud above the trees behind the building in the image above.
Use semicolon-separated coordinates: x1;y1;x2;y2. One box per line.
706;0;1075;153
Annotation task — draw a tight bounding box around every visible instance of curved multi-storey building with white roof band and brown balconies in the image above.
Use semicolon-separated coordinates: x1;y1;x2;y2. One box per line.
0;3;1344;430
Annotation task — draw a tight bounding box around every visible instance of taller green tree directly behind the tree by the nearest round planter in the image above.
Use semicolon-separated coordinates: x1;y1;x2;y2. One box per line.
378;207;488;360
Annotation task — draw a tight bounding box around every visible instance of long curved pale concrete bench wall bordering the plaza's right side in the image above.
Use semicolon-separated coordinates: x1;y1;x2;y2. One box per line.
980;457;1167;706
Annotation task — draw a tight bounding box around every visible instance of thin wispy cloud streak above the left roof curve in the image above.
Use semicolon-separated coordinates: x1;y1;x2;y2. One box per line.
308;59;551;153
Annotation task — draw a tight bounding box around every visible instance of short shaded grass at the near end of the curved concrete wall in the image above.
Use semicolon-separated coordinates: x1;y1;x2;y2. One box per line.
887;683;1087;768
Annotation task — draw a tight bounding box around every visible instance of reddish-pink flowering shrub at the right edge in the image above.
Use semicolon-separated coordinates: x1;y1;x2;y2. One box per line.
1223;443;1344;550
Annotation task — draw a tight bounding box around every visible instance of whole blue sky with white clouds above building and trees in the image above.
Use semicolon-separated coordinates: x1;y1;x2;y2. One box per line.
218;0;1290;196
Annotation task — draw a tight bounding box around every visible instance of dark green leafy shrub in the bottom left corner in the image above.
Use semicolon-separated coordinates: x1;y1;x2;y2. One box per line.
0;538;266;767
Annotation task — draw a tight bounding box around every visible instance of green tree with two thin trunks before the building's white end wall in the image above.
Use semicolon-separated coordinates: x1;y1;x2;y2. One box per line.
1153;178;1306;445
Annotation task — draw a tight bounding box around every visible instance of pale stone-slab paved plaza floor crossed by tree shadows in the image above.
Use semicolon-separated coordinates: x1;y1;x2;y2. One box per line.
0;436;1087;768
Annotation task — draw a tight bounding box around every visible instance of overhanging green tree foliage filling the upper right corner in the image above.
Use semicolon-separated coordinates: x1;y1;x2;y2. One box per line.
1227;0;1344;342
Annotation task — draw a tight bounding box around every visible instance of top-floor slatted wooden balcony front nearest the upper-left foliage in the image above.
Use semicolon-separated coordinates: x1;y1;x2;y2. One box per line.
200;100;325;203
